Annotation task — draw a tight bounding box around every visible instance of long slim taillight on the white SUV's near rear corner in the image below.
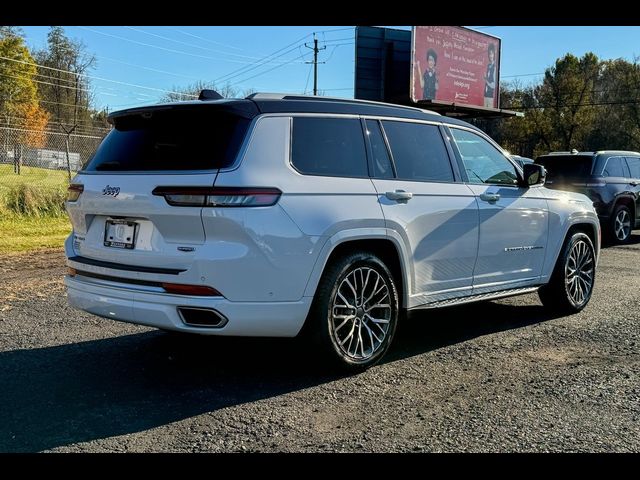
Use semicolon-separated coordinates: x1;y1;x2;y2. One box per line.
152;187;282;207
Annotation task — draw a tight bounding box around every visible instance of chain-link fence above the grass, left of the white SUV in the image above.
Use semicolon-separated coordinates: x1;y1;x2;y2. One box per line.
0;127;109;187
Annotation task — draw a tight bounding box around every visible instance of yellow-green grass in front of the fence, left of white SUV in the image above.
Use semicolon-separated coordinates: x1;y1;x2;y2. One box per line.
0;164;71;254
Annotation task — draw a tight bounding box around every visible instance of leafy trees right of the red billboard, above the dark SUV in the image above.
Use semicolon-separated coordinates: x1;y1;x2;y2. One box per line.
497;53;616;157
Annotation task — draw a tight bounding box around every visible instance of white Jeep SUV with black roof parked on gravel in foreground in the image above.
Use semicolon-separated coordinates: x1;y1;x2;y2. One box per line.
65;94;600;369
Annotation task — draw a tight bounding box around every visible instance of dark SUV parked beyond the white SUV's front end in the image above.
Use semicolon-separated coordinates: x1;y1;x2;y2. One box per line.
536;150;640;243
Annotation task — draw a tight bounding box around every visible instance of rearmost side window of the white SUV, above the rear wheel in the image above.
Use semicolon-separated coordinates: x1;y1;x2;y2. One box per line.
291;117;369;177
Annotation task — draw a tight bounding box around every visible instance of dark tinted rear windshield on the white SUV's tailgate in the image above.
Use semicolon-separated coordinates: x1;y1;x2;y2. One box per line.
85;108;250;171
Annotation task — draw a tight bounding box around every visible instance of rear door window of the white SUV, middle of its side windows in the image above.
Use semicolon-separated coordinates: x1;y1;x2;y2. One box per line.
382;120;453;182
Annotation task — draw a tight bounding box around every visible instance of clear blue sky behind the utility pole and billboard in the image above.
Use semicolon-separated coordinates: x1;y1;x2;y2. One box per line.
22;25;640;110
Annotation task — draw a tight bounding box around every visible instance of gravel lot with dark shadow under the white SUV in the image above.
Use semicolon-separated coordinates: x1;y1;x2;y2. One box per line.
0;238;640;452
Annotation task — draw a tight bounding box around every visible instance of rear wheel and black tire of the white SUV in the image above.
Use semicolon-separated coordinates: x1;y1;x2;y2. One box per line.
301;252;398;372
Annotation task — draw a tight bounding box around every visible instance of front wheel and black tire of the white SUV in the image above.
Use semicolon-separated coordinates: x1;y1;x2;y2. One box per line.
538;232;596;314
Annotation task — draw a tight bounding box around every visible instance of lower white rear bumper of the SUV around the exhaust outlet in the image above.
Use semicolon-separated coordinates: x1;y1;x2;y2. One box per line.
64;276;312;337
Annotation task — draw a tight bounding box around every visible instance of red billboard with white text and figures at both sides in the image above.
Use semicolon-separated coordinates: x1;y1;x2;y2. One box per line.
410;26;500;108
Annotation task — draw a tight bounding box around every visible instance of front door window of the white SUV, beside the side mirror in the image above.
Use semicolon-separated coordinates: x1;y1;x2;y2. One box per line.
451;127;518;185
